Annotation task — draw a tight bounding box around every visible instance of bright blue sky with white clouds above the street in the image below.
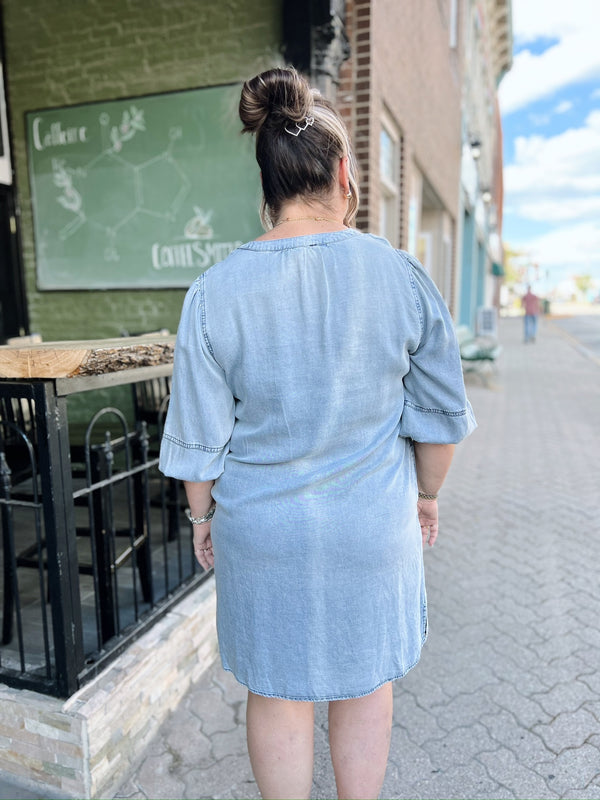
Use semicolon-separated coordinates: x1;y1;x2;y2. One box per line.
499;0;600;289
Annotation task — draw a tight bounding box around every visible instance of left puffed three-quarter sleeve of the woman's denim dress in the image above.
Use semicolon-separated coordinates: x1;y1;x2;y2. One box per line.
159;275;235;482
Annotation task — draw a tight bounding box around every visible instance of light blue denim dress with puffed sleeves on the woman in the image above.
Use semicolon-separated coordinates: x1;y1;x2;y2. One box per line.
160;230;475;700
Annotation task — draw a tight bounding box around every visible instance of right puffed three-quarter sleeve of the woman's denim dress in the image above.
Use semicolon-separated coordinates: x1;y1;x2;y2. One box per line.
400;253;477;444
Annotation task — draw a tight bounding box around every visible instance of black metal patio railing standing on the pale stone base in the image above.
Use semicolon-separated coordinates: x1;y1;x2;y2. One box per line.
0;368;208;696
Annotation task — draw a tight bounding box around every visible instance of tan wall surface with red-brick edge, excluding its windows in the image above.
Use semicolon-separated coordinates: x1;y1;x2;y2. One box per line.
338;0;463;306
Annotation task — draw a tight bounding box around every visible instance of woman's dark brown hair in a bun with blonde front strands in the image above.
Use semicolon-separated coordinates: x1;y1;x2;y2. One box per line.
239;68;358;228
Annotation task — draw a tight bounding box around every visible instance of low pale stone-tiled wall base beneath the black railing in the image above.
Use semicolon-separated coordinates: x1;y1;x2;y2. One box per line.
0;577;217;800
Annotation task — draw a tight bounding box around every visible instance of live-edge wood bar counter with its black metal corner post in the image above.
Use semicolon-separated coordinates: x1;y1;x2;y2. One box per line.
0;334;175;694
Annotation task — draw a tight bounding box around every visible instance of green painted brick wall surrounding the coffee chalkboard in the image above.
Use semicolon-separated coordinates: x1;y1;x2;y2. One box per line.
2;0;282;341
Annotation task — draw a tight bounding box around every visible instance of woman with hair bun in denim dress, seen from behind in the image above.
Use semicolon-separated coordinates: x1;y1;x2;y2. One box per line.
160;69;475;798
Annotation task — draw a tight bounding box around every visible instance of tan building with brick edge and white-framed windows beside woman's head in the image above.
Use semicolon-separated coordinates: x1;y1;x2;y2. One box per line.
338;0;463;305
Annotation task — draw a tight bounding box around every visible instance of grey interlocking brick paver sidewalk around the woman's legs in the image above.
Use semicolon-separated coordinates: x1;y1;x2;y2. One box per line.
117;319;600;800
